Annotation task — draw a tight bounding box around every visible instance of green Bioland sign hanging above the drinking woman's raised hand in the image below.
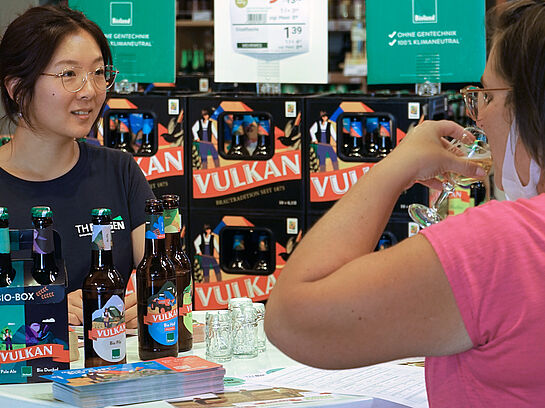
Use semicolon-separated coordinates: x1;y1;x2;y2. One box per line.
366;0;486;84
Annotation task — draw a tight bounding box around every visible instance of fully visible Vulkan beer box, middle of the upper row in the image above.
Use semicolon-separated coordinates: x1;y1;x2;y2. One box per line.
187;94;306;212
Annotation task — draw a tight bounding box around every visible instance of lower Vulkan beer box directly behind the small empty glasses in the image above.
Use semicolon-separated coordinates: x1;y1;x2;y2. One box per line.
187;210;304;310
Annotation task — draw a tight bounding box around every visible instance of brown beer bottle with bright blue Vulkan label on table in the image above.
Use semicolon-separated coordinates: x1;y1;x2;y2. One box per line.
136;199;178;360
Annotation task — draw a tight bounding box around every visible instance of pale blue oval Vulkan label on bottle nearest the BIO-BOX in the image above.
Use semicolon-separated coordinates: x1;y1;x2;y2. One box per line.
87;295;126;363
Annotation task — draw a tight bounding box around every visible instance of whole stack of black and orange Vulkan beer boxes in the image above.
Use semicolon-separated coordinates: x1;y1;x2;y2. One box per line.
99;93;447;310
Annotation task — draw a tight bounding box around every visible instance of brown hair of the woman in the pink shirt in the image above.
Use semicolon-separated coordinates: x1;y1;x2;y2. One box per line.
489;0;545;169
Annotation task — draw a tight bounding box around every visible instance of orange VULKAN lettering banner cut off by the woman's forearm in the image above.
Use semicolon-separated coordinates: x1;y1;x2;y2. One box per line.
310;164;372;202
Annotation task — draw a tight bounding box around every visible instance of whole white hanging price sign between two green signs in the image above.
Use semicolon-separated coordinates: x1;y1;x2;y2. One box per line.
214;0;328;84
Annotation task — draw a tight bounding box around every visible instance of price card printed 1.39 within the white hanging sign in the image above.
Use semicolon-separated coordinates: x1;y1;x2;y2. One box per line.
230;0;308;55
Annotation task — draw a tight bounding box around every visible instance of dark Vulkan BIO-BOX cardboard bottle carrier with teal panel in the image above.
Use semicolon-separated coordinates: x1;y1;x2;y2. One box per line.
0;229;70;384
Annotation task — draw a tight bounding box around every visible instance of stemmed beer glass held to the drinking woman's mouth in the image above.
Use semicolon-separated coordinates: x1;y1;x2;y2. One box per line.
408;127;492;228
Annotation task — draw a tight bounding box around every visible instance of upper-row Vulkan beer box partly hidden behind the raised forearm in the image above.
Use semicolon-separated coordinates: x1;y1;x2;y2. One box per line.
304;95;447;215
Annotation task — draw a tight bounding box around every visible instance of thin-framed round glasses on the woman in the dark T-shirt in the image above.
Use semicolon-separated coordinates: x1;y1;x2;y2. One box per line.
42;65;119;92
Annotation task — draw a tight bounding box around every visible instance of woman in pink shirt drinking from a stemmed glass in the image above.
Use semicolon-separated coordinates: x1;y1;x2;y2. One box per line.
265;0;545;407
